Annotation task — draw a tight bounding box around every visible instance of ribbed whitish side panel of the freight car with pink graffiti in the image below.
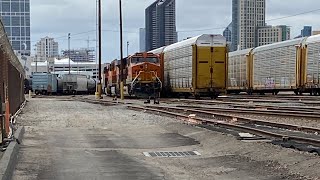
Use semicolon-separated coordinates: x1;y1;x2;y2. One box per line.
253;44;297;90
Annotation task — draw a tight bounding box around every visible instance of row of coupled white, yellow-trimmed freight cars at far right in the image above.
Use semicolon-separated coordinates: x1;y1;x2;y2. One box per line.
228;35;320;95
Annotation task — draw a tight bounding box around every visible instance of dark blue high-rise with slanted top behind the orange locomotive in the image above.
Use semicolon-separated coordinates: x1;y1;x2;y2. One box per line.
145;0;177;51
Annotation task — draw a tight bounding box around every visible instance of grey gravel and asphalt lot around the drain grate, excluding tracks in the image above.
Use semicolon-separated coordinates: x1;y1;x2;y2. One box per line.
13;99;320;180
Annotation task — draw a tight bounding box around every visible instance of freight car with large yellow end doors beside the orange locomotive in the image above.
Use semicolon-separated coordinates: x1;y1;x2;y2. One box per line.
151;34;228;98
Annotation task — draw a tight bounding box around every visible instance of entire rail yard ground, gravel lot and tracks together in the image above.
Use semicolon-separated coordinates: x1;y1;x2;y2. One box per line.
6;95;320;180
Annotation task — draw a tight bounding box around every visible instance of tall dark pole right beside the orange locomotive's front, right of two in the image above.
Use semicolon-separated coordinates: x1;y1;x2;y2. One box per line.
119;0;124;100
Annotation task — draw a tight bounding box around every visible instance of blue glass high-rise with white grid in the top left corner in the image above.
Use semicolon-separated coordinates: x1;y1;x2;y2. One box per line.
0;0;31;56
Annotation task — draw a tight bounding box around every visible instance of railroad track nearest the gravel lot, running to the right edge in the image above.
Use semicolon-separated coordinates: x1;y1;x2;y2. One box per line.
128;105;320;147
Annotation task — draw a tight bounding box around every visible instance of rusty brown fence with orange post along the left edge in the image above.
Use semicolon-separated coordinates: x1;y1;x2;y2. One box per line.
0;21;25;143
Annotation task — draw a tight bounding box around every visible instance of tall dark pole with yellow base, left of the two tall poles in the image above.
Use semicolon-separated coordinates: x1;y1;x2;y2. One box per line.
96;0;102;99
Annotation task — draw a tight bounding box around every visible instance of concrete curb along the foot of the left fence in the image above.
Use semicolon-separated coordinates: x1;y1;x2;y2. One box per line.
0;127;25;180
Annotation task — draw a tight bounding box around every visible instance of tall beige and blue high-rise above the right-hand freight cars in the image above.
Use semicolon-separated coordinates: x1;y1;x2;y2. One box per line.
231;0;266;50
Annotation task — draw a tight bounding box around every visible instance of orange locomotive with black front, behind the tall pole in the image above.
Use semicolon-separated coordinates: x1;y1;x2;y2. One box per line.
105;53;162;98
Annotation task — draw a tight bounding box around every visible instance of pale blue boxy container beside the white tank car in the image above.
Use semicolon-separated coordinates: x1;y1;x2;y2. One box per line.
32;73;58;95
